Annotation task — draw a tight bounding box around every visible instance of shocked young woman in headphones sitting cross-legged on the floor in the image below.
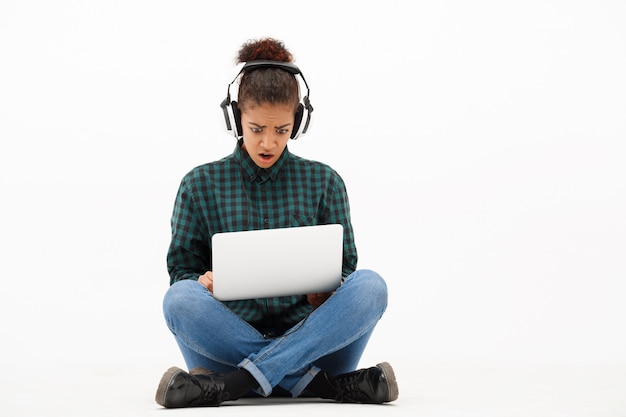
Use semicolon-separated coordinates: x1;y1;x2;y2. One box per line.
156;38;398;408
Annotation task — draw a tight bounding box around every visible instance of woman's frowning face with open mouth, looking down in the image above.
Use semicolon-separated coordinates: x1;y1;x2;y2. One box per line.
241;103;294;168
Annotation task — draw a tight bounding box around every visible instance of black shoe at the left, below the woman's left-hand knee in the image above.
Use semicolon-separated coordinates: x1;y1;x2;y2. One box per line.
156;367;225;408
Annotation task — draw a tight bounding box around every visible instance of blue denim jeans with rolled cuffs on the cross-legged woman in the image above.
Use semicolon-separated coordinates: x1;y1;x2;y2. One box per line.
163;270;387;397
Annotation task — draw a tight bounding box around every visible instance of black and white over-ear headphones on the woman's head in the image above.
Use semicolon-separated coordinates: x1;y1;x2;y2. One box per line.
220;60;313;140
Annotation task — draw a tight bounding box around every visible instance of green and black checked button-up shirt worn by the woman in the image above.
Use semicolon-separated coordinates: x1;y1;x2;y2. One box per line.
167;146;357;326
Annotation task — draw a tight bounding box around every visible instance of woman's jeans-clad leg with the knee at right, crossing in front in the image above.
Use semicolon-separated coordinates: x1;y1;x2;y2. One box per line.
238;270;387;396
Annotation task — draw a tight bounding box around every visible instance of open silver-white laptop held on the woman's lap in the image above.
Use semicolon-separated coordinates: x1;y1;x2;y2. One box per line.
212;224;343;301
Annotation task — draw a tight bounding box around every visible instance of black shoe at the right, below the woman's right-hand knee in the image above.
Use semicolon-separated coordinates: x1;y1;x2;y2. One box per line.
335;362;398;404
